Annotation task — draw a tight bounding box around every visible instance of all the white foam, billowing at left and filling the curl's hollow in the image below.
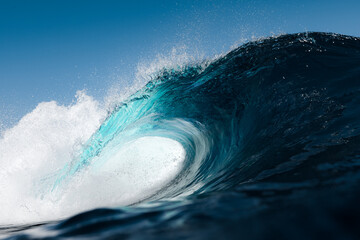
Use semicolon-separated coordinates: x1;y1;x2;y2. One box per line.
0;89;185;225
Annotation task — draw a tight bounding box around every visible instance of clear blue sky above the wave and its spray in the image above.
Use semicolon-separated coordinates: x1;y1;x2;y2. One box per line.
0;0;360;126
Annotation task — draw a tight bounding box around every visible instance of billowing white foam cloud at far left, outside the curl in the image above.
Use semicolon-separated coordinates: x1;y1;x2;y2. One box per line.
0;92;105;224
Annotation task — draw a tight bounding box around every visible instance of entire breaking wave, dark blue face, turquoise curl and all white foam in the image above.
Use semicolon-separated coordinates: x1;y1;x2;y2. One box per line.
0;33;360;240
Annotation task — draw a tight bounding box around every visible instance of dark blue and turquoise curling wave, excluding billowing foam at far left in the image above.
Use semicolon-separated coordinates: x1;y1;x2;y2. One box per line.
4;33;360;239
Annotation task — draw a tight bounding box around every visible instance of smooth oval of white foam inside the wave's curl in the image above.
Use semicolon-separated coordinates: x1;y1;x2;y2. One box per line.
56;137;185;211
